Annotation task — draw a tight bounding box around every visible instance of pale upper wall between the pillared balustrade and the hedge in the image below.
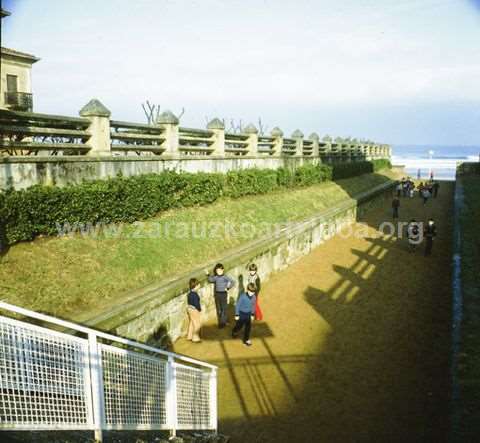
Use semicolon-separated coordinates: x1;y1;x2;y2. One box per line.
0;156;320;190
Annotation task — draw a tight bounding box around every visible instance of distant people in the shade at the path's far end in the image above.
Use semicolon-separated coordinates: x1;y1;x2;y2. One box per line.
392;175;440;256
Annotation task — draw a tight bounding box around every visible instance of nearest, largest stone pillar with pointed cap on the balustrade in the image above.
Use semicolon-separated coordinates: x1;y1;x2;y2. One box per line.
79;98;112;156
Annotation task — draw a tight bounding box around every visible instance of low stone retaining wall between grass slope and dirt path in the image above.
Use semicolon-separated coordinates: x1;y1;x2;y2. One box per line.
84;182;395;345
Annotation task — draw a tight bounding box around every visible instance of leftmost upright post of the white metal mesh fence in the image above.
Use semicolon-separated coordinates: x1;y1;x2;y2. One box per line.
88;332;105;442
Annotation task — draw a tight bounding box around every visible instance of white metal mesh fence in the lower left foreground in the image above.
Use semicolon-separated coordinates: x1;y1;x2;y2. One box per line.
0;302;217;440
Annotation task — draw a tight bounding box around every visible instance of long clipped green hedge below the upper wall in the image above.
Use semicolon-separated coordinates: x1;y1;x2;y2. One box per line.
0;160;390;246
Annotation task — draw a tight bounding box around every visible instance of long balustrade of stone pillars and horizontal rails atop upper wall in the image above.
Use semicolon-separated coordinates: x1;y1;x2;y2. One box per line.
0;99;391;161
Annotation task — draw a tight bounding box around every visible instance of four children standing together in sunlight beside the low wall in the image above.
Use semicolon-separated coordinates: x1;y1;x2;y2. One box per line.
187;263;263;346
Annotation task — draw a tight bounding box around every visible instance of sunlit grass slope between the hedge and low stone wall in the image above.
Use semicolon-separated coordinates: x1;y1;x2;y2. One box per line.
0;170;396;319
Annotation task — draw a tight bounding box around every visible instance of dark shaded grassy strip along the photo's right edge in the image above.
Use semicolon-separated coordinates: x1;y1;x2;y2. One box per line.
459;176;480;441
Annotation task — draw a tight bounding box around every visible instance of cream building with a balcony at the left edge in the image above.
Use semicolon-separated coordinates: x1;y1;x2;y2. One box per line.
0;9;40;112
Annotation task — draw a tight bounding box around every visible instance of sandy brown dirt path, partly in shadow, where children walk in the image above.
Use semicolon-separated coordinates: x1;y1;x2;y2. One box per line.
175;184;453;443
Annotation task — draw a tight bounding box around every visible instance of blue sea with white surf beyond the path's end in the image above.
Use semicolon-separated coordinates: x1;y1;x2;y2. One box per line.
392;145;480;180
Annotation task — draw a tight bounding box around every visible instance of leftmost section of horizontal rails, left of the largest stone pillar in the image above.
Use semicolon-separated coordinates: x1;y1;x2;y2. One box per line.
0;110;90;155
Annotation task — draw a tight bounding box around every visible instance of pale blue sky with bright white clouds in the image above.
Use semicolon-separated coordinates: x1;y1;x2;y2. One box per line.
2;0;480;146
